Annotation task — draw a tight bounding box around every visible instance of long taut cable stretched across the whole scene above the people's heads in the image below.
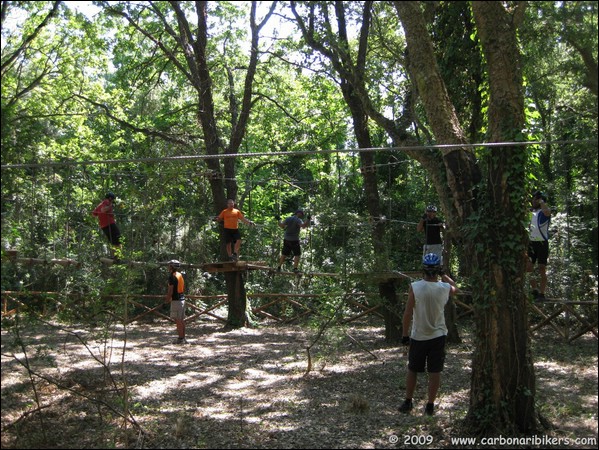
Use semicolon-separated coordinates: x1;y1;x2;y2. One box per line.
0;139;597;170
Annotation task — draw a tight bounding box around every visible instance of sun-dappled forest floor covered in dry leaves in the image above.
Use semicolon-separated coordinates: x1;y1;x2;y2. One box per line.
1;317;598;448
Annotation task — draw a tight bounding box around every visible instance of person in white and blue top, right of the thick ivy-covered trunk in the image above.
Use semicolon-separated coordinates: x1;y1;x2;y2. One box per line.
526;191;551;301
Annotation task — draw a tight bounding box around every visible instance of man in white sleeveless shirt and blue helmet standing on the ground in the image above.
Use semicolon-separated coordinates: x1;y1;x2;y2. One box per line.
399;253;458;416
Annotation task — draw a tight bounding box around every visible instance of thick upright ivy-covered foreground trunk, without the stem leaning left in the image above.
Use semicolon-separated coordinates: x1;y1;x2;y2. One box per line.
467;2;538;434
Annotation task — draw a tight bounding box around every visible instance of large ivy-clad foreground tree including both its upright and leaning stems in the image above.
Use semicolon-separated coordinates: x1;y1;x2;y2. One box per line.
395;2;537;433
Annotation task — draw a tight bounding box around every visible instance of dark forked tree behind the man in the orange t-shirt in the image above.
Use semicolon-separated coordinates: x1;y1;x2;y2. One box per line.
105;1;277;328
